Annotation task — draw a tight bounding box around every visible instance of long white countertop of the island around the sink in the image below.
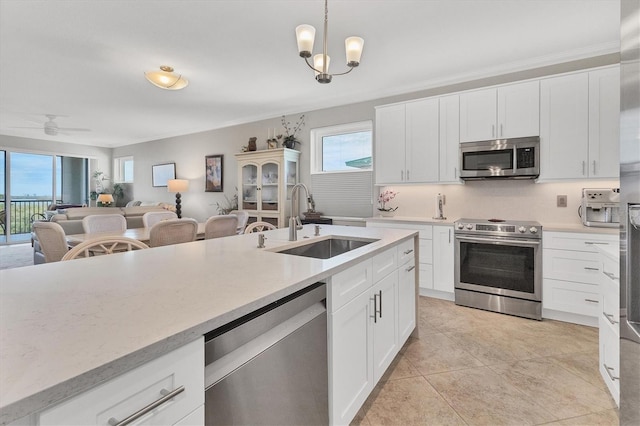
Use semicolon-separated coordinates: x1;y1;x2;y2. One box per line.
0;225;416;424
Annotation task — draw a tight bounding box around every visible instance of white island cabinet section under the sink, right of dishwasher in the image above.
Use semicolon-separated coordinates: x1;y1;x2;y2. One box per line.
328;239;416;425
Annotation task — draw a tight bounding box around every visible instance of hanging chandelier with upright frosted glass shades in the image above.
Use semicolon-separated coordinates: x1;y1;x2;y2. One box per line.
296;0;364;84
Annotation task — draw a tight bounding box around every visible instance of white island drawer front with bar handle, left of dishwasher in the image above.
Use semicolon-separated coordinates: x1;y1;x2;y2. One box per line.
39;338;204;426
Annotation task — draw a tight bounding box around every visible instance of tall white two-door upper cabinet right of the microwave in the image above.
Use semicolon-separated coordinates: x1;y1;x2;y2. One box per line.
540;67;620;180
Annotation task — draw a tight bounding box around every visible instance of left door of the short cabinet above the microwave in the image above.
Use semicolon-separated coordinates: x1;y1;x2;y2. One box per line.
460;89;497;142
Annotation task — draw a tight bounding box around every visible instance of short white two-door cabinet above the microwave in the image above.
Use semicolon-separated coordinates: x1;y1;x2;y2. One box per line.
460;81;540;142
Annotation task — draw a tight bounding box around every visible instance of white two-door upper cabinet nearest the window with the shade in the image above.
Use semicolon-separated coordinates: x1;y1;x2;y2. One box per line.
375;98;439;184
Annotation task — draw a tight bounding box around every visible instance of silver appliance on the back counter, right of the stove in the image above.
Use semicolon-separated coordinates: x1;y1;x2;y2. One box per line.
579;188;620;228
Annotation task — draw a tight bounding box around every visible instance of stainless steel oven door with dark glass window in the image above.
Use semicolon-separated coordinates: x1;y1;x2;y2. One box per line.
455;235;542;301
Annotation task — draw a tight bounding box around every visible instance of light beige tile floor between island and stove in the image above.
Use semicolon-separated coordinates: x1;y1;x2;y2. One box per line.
352;297;619;426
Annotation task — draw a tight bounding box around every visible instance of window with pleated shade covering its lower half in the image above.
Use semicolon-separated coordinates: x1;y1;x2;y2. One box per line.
311;121;373;217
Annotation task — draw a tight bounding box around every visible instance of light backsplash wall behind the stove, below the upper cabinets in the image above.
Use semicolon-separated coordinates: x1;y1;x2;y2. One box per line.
380;180;620;224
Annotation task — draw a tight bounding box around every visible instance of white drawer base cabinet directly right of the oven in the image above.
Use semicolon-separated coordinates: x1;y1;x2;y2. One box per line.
542;231;618;327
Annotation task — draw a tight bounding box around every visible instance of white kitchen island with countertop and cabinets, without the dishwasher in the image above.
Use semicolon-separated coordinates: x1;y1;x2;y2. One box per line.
0;225;417;426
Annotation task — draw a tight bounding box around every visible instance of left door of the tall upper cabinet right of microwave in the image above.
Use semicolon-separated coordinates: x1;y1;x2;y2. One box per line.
540;73;589;179
